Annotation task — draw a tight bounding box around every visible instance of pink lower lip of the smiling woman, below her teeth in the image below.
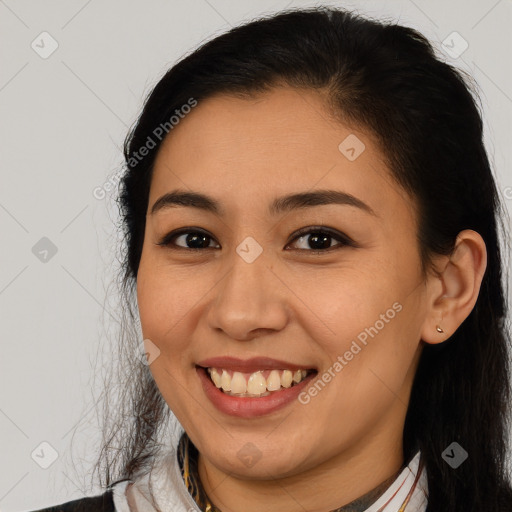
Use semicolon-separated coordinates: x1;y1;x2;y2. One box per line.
196;366;316;418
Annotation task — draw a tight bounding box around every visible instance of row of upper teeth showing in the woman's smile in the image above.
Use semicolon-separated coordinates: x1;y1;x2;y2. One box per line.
208;368;307;396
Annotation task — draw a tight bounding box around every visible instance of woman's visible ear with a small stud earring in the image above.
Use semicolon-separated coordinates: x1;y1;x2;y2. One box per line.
421;229;487;344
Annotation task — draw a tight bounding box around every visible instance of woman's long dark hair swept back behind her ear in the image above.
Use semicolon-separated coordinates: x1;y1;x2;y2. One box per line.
95;7;512;512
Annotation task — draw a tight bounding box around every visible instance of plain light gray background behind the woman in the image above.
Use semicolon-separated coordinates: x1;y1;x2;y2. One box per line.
0;0;512;511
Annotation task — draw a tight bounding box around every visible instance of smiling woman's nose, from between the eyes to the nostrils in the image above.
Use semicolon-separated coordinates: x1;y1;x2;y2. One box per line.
207;248;289;341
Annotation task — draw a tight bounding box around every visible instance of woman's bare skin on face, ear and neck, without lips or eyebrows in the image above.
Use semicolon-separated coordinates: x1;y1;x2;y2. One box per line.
137;87;486;512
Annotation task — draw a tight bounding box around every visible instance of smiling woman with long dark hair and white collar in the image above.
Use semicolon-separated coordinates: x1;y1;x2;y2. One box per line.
30;8;512;512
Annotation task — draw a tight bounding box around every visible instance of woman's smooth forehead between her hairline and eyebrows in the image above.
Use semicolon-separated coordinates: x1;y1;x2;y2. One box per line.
149;88;412;222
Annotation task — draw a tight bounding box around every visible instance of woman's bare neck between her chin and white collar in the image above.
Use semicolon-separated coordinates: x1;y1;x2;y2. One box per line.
198;428;404;512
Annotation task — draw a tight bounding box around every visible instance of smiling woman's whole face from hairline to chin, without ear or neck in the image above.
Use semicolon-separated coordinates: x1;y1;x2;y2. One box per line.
137;88;427;479
